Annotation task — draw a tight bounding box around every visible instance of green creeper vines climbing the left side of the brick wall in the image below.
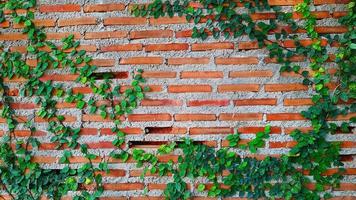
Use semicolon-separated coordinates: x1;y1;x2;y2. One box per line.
0;0;147;200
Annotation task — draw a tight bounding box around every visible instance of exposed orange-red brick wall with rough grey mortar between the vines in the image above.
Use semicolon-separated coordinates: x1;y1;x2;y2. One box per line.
0;0;356;199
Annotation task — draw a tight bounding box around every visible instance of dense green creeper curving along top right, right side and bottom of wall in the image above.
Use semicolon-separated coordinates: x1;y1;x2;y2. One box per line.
132;0;356;199
